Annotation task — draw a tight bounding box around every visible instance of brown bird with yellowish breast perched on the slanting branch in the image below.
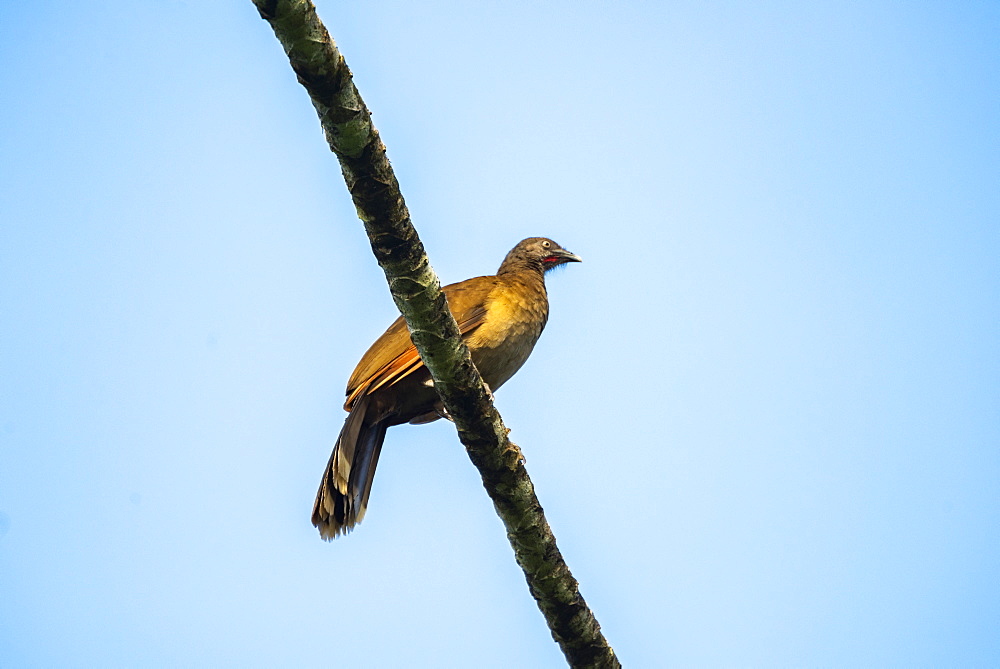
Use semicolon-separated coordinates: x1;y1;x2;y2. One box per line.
312;237;582;541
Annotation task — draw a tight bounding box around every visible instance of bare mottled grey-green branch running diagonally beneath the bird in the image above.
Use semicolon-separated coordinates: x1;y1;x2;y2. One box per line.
254;0;621;667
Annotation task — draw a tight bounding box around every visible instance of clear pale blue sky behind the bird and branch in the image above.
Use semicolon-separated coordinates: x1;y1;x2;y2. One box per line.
0;0;1000;668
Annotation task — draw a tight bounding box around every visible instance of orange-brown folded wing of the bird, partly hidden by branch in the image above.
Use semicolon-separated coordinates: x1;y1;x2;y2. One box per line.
344;276;496;410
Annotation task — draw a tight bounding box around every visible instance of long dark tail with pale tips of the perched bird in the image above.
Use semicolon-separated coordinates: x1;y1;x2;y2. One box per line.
312;396;388;541
